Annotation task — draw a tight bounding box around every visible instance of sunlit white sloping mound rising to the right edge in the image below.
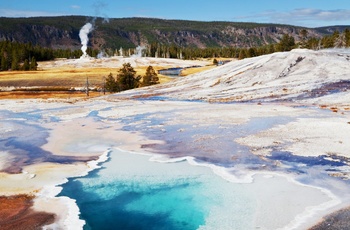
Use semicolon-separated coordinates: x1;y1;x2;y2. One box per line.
115;49;350;107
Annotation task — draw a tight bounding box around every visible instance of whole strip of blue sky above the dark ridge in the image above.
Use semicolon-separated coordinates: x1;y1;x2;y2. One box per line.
0;0;350;27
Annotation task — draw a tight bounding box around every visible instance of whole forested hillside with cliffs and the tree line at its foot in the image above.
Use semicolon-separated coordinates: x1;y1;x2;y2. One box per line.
0;16;350;71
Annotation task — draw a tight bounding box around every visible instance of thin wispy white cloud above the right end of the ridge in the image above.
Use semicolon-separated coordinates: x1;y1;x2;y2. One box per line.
232;8;350;27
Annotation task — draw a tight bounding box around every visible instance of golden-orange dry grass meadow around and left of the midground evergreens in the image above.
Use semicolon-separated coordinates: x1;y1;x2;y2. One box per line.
0;60;215;99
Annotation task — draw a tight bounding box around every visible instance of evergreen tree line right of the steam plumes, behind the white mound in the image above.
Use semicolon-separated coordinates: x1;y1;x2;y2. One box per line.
123;29;350;60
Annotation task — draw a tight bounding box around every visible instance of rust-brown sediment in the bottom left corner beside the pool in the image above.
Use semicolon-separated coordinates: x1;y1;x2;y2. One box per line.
0;195;55;230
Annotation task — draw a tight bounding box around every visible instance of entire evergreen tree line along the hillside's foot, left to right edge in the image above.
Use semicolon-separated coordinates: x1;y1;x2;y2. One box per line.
0;29;350;71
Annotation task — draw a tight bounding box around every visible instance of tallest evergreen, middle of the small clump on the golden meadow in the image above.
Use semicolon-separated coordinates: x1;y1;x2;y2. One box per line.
117;63;141;90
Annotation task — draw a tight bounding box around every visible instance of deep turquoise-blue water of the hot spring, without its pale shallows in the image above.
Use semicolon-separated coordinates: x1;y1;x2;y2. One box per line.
61;173;204;229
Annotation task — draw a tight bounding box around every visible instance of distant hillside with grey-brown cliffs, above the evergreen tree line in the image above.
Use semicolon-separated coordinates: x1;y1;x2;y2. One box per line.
0;16;338;49
